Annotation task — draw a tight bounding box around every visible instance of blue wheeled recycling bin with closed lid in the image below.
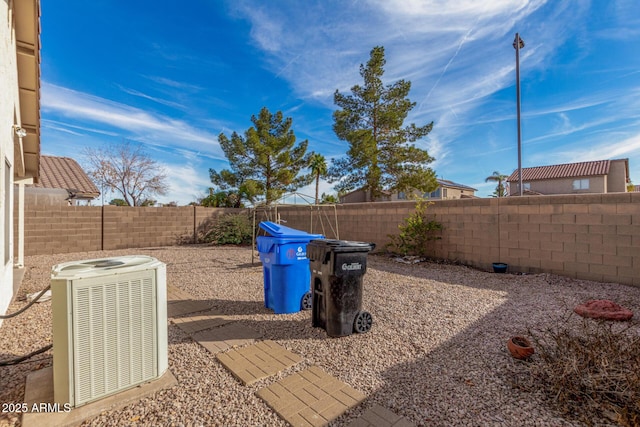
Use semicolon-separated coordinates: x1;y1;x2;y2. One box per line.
257;221;324;314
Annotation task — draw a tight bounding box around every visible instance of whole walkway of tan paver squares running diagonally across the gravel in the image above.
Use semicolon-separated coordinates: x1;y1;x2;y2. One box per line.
167;286;413;427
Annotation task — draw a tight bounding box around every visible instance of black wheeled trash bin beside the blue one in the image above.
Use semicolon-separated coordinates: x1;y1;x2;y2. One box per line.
307;239;375;337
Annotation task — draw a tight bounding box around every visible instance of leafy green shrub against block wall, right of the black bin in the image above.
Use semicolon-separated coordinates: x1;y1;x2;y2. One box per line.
387;199;443;256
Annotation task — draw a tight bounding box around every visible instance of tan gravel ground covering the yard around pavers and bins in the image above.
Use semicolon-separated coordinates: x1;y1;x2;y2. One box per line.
0;246;640;426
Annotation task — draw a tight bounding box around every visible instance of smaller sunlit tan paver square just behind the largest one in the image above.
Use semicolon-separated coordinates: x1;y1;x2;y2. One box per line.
216;340;302;385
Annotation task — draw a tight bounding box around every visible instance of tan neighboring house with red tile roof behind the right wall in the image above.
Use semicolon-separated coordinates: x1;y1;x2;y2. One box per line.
507;159;629;196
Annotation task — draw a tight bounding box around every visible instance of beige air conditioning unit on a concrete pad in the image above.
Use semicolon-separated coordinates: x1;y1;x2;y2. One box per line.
51;255;168;407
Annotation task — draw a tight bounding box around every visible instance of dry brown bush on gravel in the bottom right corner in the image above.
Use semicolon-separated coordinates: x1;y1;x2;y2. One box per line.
512;311;640;426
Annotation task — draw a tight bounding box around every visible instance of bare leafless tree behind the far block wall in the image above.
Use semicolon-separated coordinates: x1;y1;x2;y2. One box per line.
84;141;169;206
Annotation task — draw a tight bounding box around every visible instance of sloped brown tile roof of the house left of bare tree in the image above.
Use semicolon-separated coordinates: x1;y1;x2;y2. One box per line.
33;156;100;197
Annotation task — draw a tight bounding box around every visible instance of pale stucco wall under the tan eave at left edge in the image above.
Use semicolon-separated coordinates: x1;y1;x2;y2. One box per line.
0;0;20;322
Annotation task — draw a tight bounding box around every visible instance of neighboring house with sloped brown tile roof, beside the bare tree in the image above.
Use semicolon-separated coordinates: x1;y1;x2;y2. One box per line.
25;156;100;205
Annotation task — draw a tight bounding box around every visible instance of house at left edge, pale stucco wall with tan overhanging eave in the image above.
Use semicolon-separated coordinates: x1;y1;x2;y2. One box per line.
0;0;40;323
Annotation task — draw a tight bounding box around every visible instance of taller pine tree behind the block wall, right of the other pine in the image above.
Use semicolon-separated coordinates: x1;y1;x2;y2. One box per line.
329;46;438;200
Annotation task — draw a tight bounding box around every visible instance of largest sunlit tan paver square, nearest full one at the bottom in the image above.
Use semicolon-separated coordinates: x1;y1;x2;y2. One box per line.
256;366;366;427
